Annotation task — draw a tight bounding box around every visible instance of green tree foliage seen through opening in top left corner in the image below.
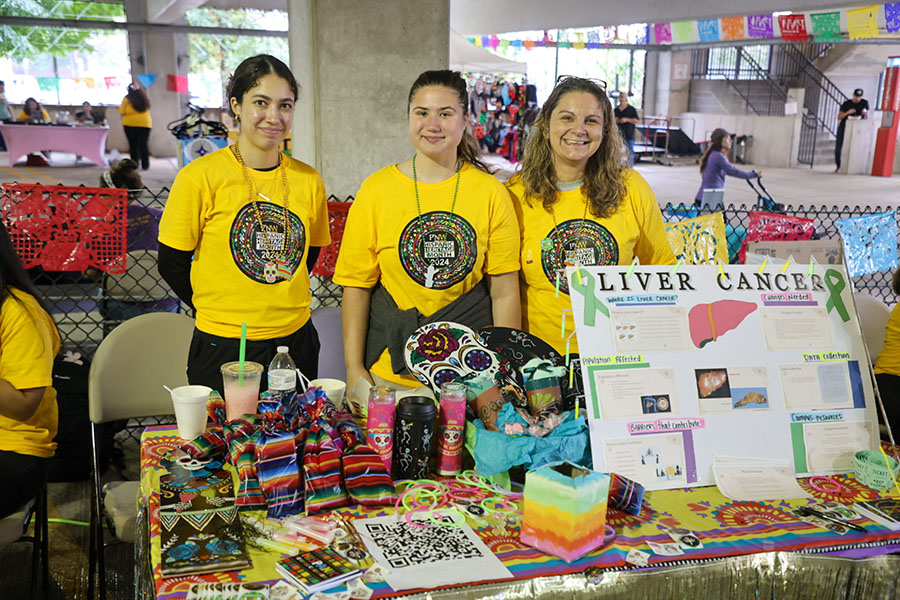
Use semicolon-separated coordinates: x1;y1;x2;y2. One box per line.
0;0;125;61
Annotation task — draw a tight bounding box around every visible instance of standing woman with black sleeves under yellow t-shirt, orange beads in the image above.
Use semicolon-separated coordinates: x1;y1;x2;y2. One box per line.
159;54;331;392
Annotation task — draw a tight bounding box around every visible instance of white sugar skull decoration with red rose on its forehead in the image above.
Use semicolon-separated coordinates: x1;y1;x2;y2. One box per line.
404;322;500;394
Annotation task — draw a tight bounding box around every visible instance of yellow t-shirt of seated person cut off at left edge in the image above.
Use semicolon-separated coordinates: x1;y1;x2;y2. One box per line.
0;287;59;458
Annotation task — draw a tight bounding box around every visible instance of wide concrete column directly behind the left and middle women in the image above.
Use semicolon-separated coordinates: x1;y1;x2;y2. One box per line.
288;0;450;198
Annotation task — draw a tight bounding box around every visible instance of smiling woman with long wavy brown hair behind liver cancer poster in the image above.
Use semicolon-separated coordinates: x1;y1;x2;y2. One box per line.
508;76;675;354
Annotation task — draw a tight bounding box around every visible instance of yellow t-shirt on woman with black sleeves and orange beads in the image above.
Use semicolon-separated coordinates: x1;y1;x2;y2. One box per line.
159;148;331;340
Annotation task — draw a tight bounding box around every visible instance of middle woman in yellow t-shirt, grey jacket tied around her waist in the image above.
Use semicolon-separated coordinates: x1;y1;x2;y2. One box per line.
334;71;521;403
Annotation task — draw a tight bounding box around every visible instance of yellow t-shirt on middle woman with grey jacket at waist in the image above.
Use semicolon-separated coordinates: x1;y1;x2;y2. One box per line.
334;164;519;387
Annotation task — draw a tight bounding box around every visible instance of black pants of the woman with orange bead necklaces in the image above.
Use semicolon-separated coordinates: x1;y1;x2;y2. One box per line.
188;320;319;394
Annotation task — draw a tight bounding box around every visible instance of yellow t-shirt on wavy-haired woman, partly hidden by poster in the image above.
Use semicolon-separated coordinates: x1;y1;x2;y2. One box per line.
508;169;675;353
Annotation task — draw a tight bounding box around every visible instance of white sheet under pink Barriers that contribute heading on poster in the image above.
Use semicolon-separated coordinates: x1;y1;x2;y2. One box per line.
603;433;693;489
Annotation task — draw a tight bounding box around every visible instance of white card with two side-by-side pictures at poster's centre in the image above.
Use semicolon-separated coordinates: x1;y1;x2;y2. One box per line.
694;367;769;413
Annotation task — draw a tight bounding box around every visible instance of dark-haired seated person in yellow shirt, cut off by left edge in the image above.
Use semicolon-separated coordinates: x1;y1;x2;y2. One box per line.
0;222;59;518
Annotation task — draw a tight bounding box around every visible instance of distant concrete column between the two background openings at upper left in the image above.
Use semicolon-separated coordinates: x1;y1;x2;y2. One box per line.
125;0;190;158
